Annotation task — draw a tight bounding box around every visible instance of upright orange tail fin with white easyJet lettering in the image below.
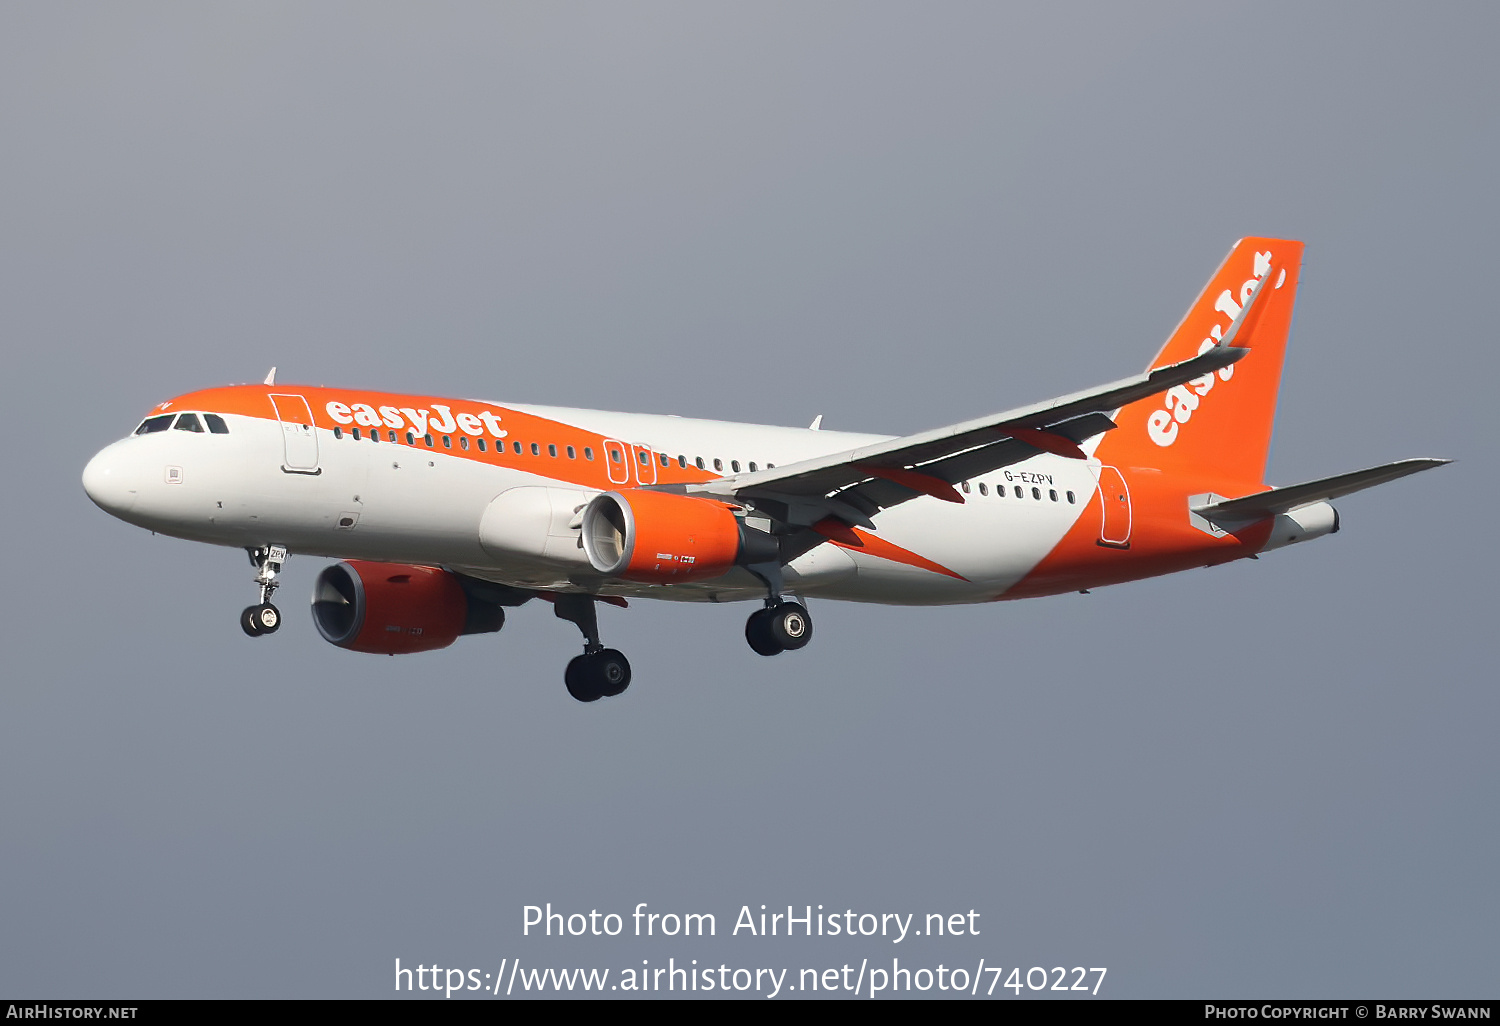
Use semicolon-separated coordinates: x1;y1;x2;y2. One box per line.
1095;239;1302;495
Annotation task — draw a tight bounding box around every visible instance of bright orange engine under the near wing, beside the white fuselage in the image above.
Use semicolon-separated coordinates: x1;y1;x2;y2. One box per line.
584;488;779;584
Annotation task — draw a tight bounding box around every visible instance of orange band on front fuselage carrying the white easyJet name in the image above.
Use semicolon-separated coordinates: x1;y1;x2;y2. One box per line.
147;386;719;491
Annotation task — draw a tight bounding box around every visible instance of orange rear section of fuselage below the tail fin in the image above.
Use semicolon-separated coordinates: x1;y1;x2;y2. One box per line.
999;468;1271;599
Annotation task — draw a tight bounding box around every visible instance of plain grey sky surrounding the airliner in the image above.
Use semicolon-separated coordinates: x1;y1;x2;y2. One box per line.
0;3;1500;998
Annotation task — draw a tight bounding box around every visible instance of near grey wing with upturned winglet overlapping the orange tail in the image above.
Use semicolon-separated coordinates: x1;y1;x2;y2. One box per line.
687;342;1251;528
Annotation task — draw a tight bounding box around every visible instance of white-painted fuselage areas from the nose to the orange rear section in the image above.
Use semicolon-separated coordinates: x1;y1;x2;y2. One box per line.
84;404;1098;605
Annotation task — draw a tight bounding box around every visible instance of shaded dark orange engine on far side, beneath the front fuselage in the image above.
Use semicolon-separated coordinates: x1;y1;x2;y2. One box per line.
312;560;506;656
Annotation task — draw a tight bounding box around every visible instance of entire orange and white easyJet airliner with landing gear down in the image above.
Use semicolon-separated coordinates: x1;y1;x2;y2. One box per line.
83;239;1449;702
